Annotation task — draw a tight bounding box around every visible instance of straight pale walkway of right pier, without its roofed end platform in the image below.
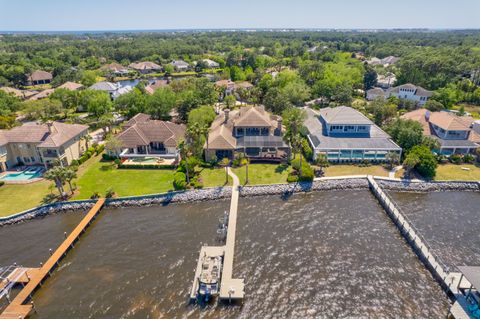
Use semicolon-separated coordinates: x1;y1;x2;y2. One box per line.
369;178;449;282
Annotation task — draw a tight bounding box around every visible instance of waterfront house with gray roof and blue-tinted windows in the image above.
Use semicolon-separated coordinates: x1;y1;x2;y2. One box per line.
305;106;402;162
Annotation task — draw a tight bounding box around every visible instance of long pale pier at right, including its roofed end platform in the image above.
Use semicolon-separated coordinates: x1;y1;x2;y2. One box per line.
367;176;471;319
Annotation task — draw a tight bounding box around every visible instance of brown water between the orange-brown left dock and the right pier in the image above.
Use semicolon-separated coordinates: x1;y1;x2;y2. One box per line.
0;191;448;319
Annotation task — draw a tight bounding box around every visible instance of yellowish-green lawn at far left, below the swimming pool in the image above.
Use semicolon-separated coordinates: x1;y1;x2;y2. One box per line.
0;181;50;216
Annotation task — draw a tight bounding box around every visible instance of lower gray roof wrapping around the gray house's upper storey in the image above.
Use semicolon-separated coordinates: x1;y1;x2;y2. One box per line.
305;107;401;151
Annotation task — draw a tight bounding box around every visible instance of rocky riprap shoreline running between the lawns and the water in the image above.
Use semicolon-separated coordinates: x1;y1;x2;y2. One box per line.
0;176;480;227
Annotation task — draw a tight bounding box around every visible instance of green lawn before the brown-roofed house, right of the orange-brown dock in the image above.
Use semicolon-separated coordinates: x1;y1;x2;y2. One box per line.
74;157;174;199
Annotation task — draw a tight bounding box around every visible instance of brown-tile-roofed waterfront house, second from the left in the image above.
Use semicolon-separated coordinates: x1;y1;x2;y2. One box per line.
116;113;185;160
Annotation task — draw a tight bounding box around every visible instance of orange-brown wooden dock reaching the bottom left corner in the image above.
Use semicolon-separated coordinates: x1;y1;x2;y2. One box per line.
0;198;105;319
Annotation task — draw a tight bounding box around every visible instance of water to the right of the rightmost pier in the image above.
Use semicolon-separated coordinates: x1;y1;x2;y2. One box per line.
391;192;480;270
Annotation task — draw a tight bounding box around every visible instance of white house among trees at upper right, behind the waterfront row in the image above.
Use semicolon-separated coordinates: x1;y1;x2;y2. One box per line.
367;83;433;106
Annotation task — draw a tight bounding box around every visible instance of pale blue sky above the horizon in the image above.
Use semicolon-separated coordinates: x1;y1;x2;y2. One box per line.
0;0;480;31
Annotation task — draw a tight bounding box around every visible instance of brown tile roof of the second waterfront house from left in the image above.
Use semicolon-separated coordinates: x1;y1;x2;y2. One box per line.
117;113;185;148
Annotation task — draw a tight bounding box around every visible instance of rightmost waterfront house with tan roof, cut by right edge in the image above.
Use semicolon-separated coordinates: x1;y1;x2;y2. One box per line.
402;109;480;155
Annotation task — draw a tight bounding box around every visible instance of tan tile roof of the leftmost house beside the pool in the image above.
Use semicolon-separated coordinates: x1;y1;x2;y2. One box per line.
0;122;88;147
